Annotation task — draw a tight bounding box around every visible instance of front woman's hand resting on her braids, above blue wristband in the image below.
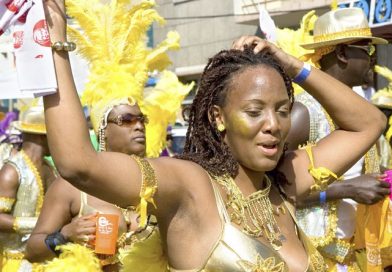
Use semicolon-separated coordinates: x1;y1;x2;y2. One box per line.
231;36;303;78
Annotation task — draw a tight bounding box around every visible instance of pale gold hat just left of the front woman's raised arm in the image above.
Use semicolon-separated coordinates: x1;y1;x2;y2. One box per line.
12;99;46;134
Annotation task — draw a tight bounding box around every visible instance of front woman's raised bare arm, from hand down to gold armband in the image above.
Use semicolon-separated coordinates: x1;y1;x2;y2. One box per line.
44;0;147;206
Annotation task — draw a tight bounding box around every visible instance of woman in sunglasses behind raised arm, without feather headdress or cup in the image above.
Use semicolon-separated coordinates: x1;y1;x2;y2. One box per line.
26;99;152;271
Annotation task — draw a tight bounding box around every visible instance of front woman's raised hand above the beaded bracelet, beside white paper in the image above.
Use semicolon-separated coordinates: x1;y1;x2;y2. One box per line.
43;0;67;42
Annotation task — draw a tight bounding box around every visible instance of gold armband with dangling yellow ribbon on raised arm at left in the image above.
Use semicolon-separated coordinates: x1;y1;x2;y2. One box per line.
131;155;158;227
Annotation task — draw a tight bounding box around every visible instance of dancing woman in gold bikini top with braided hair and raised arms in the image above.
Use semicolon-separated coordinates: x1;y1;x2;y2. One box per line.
45;0;385;271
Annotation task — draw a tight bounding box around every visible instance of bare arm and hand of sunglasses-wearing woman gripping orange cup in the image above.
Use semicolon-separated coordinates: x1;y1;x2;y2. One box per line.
26;178;95;262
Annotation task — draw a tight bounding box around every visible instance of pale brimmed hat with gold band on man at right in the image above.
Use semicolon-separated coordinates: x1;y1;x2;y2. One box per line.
301;8;388;67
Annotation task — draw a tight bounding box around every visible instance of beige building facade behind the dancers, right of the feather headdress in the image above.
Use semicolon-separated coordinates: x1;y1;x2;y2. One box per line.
153;0;392;89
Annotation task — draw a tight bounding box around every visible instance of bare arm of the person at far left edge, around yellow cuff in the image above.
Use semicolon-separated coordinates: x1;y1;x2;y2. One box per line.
0;164;19;232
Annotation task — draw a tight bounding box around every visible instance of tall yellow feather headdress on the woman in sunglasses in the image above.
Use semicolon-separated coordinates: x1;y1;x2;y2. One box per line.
66;0;192;157
